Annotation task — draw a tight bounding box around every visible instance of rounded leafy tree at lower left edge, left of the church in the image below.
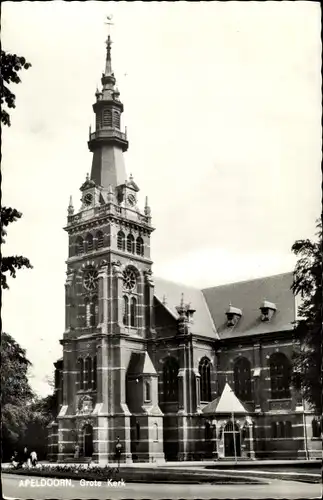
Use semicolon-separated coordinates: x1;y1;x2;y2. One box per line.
0;333;33;458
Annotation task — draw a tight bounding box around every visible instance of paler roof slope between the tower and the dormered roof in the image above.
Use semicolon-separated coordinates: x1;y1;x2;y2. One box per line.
154;278;218;338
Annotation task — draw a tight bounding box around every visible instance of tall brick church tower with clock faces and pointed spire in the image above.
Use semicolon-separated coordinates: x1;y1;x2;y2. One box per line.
52;28;164;463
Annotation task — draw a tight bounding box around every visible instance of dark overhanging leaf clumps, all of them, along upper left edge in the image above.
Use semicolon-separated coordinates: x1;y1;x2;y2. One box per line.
0;50;32;289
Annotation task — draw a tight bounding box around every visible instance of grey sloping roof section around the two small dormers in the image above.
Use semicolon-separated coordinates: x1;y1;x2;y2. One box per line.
202;272;296;339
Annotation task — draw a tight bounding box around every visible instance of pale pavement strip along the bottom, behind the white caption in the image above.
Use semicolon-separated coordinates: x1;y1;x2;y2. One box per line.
2;473;322;500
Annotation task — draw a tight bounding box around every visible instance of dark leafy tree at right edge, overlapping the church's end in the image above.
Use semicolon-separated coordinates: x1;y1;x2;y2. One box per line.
292;222;322;415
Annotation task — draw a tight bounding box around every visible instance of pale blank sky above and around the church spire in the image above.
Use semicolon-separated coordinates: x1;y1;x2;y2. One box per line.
2;1;322;395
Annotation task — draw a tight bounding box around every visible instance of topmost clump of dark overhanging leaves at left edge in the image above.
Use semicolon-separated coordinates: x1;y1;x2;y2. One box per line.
0;50;31;127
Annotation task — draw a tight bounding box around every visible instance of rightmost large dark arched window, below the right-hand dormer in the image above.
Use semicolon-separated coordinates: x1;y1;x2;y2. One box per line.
269;352;291;399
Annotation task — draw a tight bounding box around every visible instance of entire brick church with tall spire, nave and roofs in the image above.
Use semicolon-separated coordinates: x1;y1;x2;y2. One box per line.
48;36;321;464
